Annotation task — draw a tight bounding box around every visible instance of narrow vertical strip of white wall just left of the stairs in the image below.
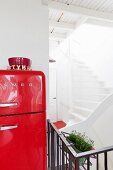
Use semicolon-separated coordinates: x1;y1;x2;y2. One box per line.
52;41;71;122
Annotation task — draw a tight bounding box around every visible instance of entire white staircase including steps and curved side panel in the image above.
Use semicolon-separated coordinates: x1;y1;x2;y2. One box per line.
58;58;113;170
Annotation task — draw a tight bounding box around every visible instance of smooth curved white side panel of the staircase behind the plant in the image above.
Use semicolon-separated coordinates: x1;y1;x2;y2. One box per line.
61;94;113;170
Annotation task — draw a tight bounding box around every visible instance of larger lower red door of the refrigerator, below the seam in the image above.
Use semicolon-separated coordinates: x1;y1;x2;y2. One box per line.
0;113;47;170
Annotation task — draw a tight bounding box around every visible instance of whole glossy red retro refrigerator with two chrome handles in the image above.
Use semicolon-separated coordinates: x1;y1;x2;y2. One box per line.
0;70;46;170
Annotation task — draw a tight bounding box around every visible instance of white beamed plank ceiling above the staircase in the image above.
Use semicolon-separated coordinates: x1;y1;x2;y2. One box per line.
42;0;113;56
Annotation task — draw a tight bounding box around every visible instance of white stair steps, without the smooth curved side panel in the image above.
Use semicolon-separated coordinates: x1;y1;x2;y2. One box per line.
66;58;112;126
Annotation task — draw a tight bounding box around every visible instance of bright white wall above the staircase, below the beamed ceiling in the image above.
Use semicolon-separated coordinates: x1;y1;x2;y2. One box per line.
70;24;113;87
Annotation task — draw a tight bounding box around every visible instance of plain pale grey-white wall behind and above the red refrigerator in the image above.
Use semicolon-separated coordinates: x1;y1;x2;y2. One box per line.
0;0;49;111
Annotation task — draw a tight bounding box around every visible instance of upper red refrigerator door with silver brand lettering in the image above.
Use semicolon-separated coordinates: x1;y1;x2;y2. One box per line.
0;70;46;115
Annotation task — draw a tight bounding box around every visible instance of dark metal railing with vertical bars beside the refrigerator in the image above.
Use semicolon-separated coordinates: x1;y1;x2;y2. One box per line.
47;120;113;170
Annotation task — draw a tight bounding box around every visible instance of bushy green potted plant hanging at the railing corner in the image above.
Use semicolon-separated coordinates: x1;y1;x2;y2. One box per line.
63;131;94;166
